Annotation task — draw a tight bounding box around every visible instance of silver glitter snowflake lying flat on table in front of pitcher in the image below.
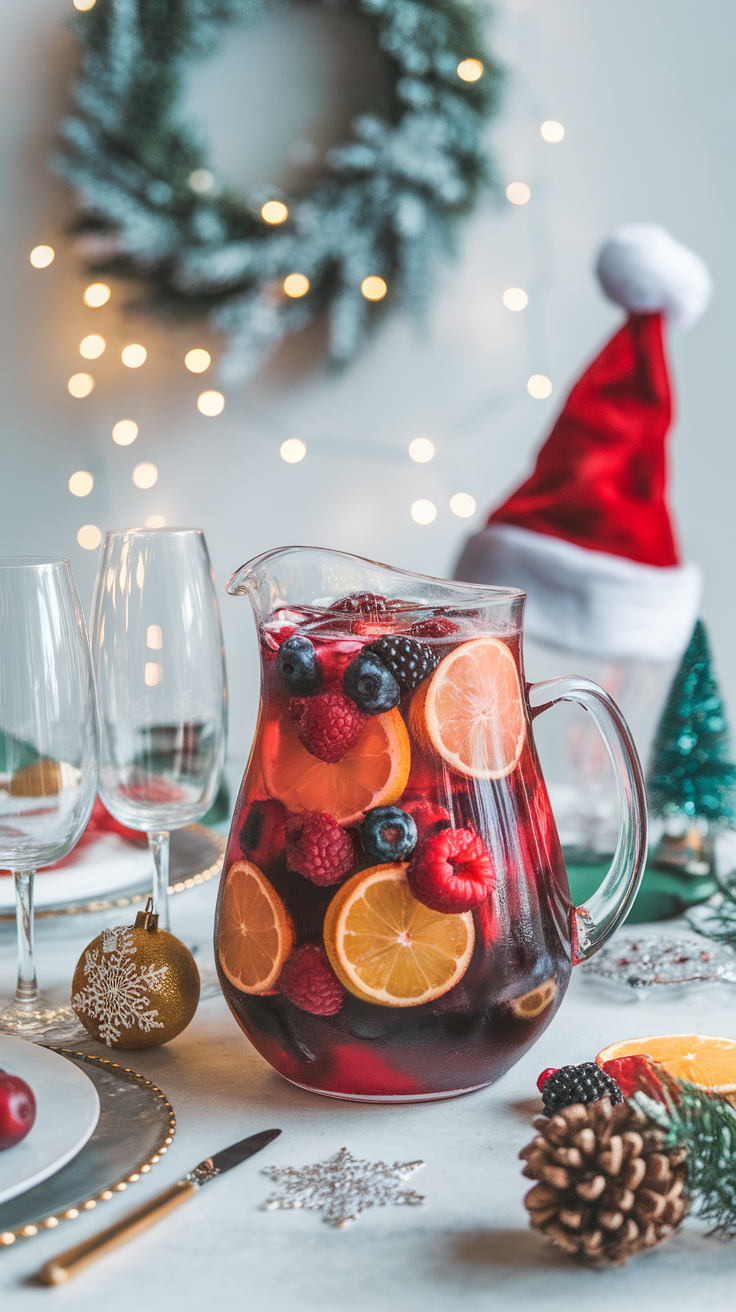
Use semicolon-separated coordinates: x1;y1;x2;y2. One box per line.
264;1148;424;1229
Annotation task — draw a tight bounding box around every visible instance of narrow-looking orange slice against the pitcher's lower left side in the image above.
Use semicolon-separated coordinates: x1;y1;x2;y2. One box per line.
218;861;294;993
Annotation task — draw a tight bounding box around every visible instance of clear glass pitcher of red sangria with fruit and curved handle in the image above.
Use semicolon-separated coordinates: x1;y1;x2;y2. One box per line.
215;547;647;1102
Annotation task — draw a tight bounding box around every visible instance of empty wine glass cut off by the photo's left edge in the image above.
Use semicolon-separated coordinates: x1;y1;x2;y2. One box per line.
0;556;98;1042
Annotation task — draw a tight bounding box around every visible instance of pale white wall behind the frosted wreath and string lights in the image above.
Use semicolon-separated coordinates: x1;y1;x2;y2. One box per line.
0;0;736;753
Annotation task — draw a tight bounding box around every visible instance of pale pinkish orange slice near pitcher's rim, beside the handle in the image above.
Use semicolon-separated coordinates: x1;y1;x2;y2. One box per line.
416;638;526;779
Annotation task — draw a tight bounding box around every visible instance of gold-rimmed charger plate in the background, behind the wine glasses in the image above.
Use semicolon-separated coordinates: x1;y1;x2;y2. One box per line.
0;824;227;925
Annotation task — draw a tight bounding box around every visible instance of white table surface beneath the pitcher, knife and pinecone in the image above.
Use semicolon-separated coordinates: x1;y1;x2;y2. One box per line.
0;850;736;1312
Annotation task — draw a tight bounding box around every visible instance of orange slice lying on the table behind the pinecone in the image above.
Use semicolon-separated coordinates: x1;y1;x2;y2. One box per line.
596;1034;736;1094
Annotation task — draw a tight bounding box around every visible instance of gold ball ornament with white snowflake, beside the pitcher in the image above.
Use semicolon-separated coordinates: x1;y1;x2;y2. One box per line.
72;899;199;1048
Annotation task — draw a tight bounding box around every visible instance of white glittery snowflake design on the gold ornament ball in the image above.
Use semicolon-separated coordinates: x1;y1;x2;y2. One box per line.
72;925;168;1048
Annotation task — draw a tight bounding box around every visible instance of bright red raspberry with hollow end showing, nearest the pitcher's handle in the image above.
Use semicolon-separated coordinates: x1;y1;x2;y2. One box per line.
407;829;496;913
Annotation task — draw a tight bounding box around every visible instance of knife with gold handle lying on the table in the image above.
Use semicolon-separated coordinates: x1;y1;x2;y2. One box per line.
34;1130;281;1284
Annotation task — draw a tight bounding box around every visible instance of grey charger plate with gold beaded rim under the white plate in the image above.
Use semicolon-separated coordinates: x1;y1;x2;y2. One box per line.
0;1046;176;1248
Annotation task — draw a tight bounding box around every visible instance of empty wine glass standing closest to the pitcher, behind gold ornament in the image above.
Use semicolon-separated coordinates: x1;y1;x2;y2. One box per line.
92;529;227;929
